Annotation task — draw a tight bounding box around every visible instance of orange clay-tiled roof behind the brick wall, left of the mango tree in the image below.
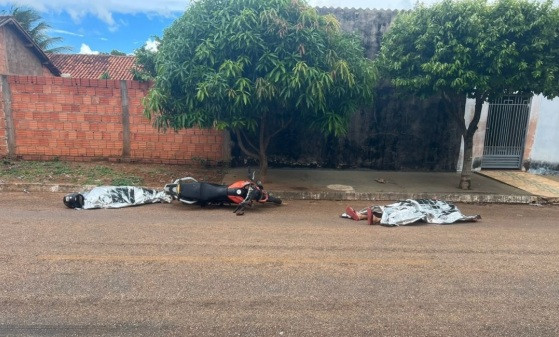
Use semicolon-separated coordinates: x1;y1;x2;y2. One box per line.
49;54;136;80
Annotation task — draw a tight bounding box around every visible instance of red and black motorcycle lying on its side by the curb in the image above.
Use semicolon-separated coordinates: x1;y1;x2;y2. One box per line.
163;169;282;215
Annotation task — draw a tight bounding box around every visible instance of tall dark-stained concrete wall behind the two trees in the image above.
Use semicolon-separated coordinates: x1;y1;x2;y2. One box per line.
250;8;460;171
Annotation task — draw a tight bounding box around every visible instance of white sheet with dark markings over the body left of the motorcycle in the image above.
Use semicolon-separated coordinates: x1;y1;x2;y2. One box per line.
82;186;172;209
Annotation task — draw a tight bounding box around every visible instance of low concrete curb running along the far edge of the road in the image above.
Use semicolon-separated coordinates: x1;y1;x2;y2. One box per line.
0;183;548;204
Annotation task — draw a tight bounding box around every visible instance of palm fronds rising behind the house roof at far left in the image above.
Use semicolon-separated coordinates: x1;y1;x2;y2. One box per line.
2;5;72;53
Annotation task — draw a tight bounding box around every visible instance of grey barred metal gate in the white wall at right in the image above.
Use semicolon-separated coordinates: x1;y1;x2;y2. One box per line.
481;95;532;169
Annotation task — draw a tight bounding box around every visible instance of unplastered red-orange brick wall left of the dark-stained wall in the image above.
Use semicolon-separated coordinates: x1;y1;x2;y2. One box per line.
0;76;228;164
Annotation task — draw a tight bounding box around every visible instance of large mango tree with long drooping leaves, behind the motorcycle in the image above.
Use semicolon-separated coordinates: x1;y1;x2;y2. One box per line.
145;0;375;176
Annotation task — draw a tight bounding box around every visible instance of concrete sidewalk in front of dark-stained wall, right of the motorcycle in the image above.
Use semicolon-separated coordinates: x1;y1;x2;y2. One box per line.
223;168;559;203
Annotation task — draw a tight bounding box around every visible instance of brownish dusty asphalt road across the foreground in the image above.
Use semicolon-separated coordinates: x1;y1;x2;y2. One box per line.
0;193;559;336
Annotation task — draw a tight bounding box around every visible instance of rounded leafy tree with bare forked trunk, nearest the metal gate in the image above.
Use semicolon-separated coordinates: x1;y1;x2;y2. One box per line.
378;0;559;189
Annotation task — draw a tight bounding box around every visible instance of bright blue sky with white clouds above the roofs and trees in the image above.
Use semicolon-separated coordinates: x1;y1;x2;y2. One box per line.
0;0;559;54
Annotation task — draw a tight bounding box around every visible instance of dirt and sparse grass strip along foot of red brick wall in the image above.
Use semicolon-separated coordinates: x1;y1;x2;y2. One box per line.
0;159;227;188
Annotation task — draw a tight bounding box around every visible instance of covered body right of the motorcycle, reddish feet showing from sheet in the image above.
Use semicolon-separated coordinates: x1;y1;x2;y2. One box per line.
341;199;481;226
